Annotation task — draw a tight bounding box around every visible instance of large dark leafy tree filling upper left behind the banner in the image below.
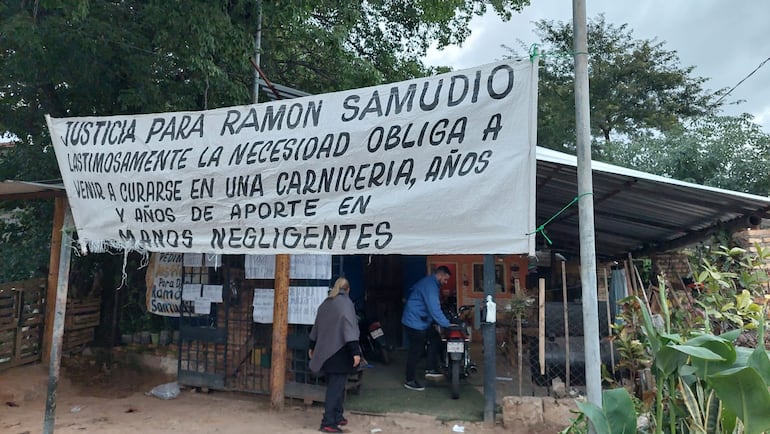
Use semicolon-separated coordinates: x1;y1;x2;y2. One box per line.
0;0;529;279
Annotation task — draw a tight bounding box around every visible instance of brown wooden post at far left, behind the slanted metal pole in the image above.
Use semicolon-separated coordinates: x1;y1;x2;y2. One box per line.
42;197;69;365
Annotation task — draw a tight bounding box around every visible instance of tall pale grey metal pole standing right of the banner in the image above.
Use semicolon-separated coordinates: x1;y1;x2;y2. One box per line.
572;0;602;408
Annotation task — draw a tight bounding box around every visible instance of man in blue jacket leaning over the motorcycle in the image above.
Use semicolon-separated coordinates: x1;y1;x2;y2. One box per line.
401;265;452;390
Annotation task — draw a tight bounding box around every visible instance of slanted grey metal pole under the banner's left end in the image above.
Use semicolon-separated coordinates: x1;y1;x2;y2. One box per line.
43;206;75;434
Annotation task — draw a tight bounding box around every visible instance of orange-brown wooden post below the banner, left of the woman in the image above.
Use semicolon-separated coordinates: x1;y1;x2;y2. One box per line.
270;254;289;410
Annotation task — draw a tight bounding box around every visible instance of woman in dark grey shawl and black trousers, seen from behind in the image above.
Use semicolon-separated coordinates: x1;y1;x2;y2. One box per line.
308;277;361;433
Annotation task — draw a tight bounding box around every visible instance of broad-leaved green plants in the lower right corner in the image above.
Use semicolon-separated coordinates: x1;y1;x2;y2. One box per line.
567;251;770;433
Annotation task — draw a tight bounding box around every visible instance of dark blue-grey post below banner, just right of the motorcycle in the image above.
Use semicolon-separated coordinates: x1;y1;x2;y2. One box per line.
481;255;497;424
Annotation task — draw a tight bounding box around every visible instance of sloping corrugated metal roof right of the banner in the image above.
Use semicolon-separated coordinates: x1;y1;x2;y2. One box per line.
536;148;770;258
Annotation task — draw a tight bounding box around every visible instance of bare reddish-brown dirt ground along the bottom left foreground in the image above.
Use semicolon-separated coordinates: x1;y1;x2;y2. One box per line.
0;358;540;434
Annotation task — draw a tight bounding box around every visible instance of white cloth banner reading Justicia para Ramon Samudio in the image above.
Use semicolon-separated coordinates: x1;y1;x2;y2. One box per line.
46;60;537;254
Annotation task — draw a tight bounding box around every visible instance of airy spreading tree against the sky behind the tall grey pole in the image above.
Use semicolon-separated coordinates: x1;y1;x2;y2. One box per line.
524;15;717;155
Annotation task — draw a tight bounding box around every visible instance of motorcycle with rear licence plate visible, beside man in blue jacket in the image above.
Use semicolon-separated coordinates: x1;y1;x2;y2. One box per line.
441;306;477;399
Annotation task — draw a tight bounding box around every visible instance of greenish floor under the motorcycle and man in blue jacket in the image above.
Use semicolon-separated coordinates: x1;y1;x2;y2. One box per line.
345;351;484;422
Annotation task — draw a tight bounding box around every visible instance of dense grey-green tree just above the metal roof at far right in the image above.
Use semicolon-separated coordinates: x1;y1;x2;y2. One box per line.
607;114;770;196
